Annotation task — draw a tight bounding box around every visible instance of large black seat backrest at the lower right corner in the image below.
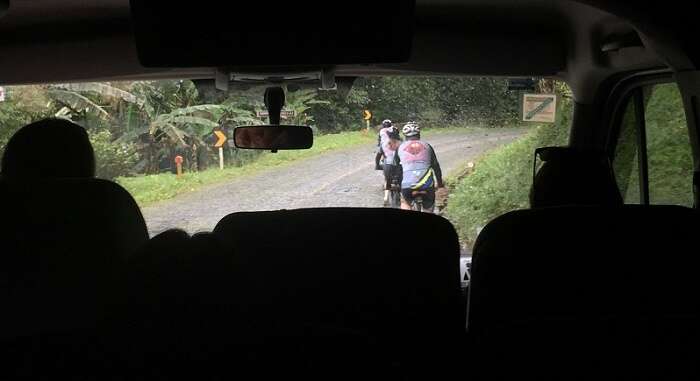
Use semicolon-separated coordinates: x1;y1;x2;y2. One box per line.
467;205;700;378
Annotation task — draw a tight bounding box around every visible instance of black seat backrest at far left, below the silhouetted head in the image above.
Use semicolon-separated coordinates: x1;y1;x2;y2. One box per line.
0;178;148;337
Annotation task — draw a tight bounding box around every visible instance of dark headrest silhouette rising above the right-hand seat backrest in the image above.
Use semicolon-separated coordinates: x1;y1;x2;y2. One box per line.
530;147;623;208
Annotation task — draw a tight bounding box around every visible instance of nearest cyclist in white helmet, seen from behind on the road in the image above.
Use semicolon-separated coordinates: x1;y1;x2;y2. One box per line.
394;122;444;213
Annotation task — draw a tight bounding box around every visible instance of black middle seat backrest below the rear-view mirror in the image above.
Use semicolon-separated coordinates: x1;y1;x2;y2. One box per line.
214;208;465;358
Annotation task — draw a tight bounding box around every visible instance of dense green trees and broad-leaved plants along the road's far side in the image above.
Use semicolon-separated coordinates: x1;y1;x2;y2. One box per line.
0;77;519;178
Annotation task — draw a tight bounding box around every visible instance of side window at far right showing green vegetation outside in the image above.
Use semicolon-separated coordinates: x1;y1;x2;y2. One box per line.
613;83;693;206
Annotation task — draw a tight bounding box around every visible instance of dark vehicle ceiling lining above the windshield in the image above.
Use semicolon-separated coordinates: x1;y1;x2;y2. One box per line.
0;0;700;103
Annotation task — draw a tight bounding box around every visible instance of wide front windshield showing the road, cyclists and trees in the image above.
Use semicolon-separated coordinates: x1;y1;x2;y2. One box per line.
0;77;571;252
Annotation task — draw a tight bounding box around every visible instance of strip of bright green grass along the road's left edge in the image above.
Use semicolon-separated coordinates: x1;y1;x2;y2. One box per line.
116;132;376;207
